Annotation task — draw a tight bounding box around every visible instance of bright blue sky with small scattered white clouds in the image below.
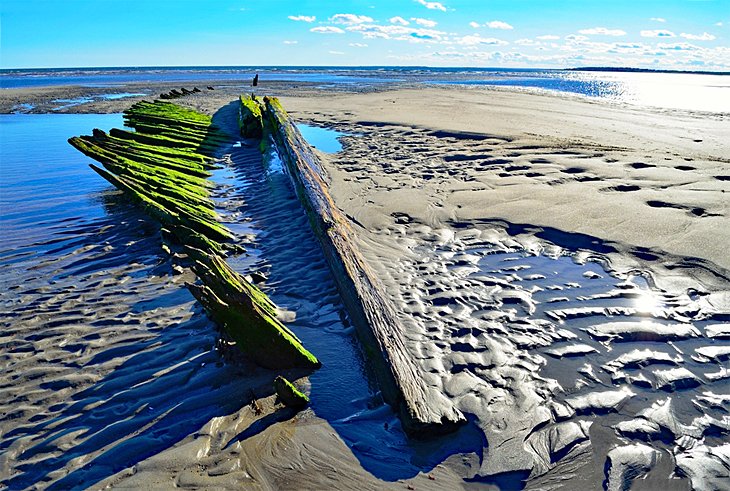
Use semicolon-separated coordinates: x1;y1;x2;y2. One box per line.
0;0;730;71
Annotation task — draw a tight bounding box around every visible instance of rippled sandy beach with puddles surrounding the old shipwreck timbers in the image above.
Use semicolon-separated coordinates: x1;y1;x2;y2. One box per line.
0;80;730;489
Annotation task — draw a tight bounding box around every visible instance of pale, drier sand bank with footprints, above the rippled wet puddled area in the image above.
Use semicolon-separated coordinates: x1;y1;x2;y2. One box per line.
276;89;730;288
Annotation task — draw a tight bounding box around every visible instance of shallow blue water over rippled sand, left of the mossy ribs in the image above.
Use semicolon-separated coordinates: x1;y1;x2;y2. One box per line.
0;114;240;489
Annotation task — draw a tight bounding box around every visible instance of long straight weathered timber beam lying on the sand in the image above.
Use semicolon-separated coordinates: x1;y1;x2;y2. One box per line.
250;98;466;435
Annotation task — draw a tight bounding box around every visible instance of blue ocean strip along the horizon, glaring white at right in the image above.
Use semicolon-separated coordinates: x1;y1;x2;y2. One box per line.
0;66;730;113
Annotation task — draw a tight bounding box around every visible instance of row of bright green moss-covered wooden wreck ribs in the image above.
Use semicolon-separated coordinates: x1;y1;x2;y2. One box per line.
69;101;319;369
